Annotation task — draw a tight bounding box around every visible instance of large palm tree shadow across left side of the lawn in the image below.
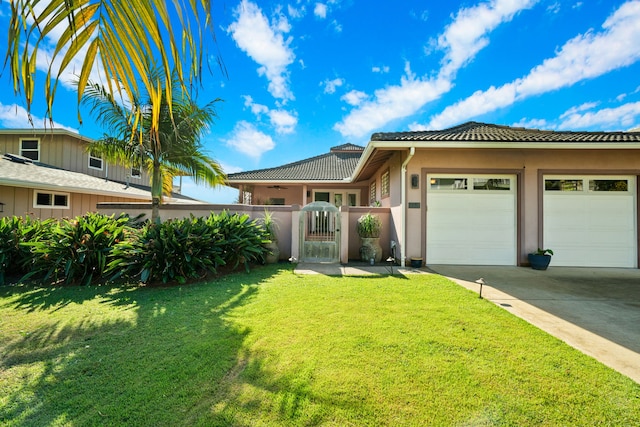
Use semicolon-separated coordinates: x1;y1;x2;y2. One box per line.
0;268;286;426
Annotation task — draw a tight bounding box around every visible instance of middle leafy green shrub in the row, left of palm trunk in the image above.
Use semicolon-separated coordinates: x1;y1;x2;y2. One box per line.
23;213;130;285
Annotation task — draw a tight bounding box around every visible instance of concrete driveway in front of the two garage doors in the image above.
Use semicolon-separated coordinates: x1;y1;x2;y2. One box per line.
429;265;640;383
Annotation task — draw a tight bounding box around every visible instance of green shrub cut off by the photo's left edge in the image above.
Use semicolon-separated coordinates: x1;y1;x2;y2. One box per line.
0;216;53;285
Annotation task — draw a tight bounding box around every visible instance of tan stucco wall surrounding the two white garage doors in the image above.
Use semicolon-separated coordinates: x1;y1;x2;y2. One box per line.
400;148;640;262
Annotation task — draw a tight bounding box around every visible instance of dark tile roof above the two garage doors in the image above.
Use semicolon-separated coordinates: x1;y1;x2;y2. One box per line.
371;122;640;143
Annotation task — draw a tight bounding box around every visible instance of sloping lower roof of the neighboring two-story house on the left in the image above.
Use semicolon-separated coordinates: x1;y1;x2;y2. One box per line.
0;155;151;200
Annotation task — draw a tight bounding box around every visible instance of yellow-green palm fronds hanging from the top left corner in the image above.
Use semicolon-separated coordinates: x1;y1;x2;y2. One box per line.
5;0;222;137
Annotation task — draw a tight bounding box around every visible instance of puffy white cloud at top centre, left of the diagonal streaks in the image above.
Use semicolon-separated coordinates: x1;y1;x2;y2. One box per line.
227;0;295;100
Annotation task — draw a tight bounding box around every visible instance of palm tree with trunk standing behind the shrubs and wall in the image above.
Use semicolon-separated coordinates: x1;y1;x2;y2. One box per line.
82;78;226;221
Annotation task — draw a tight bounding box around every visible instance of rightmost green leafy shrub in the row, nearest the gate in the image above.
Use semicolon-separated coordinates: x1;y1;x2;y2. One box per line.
108;217;225;283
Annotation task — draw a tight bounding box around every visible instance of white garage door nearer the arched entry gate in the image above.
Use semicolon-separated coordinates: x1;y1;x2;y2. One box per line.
426;174;516;265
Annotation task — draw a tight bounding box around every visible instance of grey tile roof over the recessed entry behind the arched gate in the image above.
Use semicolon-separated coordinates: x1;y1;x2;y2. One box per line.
227;144;364;184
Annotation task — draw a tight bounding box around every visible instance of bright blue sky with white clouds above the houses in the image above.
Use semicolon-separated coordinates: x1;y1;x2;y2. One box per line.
0;0;640;202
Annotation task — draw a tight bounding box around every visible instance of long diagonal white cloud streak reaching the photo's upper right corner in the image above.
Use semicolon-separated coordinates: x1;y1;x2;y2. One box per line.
427;1;640;129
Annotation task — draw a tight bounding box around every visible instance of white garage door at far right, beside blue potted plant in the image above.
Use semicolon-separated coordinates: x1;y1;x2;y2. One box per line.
543;176;637;268
